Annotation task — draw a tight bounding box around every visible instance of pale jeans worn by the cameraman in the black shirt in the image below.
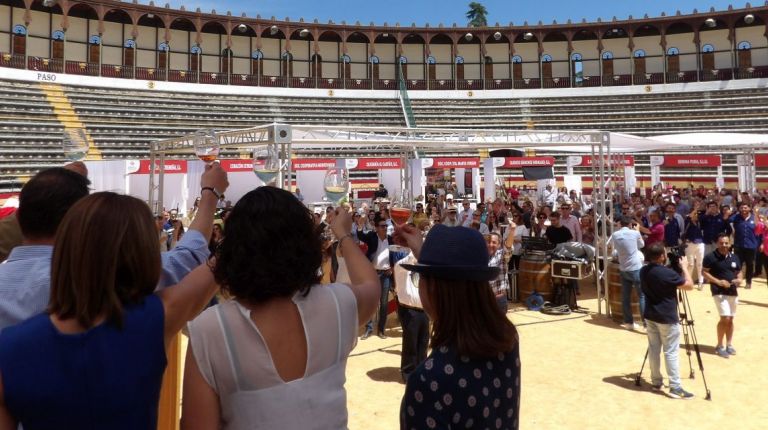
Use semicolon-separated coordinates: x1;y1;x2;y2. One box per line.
646;320;680;389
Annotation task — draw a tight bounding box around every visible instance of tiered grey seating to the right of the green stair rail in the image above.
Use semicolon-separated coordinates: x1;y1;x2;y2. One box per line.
411;88;768;136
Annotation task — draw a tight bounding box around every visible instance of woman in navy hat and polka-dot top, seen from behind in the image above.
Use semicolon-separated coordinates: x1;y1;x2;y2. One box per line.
397;225;520;429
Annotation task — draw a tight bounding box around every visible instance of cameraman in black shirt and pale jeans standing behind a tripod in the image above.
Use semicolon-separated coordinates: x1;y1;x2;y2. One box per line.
640;242;693;399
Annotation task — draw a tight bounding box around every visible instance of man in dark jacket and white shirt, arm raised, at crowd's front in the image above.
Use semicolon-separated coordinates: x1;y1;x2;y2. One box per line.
356;215;394;340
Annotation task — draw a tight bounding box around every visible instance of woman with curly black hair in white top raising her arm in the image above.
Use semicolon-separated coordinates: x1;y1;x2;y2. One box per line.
182;187;380;430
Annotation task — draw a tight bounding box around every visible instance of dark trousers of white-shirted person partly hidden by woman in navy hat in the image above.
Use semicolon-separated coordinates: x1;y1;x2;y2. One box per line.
397;305;429;382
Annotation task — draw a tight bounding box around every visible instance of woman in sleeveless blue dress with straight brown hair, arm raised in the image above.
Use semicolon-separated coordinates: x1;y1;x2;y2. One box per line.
0;193;217;430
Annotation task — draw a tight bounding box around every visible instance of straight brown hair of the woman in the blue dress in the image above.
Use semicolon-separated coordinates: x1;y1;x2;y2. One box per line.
48;192;161;328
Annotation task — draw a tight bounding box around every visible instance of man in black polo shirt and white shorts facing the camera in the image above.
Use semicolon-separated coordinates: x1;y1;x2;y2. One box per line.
702;234;742;358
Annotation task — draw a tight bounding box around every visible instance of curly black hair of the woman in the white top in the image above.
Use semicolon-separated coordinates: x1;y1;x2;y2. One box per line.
214;187;322;303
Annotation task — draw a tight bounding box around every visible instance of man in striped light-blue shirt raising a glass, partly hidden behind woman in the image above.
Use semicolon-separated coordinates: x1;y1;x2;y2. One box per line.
0;163;229;331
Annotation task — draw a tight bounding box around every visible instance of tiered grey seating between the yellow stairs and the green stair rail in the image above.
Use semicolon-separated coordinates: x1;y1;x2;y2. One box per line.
65;87;404;158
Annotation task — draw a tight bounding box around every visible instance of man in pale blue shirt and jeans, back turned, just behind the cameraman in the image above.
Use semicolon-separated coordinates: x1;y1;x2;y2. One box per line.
608;216;645;330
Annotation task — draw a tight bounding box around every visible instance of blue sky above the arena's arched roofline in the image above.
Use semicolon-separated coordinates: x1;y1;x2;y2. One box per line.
140;0;740;27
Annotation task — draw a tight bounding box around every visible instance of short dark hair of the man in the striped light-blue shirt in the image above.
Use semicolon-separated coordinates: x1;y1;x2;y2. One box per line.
16;167;91;239
